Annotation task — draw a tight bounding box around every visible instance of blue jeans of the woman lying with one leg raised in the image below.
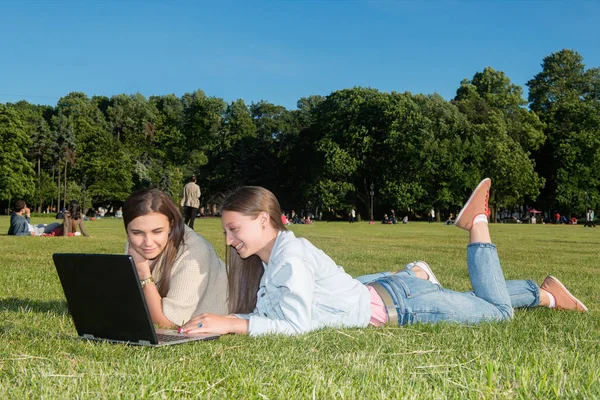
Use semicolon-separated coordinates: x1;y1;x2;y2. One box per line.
357;243;516;325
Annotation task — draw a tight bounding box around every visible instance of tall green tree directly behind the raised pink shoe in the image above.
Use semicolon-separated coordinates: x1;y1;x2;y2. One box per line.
454;67;544;220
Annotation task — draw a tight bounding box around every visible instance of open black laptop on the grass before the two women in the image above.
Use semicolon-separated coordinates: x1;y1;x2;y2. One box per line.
52;253;219;346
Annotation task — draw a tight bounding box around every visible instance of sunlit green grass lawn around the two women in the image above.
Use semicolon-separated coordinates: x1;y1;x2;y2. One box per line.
0;217;600;399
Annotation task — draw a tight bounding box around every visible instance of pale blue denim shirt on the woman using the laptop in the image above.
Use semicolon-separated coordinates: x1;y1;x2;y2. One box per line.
237;231;371;336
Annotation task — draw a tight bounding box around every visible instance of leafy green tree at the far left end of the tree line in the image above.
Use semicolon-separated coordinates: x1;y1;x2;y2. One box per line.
0;104;35;201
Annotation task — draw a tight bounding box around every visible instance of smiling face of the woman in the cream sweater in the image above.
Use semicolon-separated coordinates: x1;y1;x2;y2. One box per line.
127;212;170;260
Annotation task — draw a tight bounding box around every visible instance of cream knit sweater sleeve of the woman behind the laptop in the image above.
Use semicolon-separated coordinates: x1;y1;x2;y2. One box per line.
162;246;210;325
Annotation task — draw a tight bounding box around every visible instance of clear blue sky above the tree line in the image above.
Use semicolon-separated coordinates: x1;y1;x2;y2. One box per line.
0;0;600;109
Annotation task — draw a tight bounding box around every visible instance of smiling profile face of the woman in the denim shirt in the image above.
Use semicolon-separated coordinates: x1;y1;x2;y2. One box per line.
221;211;277;262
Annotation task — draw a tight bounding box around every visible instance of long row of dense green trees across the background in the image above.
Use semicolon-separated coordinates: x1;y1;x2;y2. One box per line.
0;49;600;217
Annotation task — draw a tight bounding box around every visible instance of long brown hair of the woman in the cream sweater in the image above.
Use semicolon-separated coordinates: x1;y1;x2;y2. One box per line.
123;189;185;297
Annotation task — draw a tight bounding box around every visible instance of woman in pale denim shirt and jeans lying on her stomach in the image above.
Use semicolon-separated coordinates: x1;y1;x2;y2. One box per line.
183;179;585;336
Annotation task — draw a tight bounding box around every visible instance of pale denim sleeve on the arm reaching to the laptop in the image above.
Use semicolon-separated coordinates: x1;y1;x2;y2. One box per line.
246;258;316;336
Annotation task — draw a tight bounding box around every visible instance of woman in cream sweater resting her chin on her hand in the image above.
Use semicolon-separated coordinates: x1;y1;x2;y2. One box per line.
123;189;227;328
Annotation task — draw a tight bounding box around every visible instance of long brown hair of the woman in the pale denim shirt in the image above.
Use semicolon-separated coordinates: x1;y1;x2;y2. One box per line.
221;186;287;313
